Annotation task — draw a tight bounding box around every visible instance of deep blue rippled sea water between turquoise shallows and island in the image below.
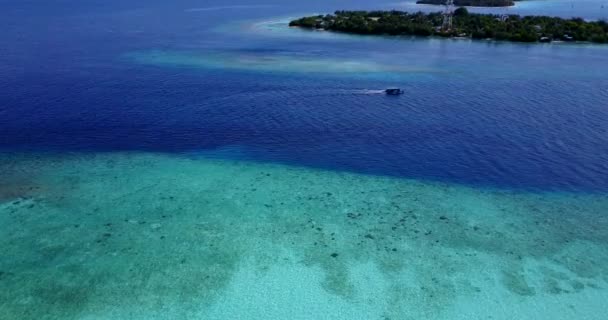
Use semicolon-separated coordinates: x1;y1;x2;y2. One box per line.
0;0;608;191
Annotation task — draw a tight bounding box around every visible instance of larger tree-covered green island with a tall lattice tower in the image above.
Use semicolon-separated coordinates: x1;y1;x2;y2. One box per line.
289;7;608;43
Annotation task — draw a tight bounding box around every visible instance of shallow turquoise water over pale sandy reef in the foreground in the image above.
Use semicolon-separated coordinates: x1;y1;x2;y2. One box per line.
0;153;608;320
